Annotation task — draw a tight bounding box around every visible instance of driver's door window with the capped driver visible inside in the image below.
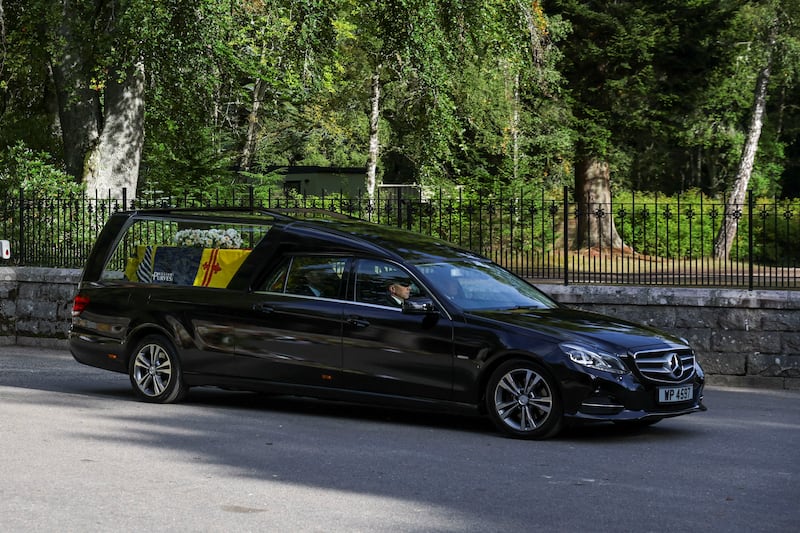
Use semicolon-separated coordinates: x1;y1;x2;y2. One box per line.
355;259;421;307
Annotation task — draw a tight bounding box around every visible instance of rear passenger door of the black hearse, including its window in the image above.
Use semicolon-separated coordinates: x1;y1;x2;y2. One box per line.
228;256;345;388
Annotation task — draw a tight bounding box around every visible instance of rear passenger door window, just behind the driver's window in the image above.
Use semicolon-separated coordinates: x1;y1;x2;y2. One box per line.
263;256;346;298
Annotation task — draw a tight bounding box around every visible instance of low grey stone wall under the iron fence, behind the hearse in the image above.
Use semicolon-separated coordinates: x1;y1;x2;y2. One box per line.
0;267;800;389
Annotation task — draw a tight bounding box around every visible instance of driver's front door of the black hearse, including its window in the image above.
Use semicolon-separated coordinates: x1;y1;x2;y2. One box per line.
342;258;453;400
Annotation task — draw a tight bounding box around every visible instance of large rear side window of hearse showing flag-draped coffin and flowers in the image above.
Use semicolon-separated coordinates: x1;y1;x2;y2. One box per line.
101;218;269;288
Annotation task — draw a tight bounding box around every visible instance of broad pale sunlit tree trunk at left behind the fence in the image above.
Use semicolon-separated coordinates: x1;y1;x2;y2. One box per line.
83;62;144;199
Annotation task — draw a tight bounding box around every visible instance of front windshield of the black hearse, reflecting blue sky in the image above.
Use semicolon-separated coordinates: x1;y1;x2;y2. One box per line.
417;260;557;310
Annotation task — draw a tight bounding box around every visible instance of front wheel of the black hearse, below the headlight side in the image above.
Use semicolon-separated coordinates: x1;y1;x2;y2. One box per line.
486;359;564;439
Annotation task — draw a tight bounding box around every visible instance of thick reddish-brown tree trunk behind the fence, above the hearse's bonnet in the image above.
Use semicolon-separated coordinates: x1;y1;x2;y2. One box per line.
573;157;625;250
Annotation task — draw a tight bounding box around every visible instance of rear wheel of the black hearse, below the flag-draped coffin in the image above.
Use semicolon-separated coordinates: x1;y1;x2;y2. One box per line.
128;335;188;403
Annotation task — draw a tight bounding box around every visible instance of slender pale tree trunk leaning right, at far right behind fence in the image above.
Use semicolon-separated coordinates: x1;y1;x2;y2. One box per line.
714;24;777;260
